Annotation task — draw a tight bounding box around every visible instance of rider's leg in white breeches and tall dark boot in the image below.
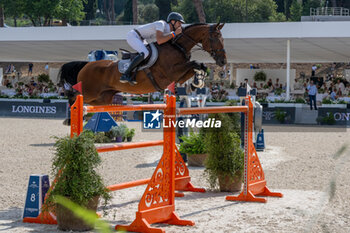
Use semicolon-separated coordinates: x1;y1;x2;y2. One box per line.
120;30;149;83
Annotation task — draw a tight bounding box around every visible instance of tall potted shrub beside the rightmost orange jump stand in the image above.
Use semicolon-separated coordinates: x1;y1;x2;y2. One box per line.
205;113;244;192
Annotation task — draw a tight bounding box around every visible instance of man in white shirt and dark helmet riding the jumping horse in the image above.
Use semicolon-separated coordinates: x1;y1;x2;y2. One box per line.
120;12;185;84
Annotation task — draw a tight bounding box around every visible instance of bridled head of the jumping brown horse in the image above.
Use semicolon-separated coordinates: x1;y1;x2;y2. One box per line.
202;23;227;66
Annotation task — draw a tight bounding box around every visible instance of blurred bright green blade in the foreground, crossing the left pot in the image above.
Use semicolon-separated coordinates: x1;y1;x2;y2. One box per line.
54;195;111;233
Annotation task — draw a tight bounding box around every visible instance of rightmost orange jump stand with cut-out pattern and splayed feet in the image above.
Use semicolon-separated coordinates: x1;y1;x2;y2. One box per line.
226;96;283;203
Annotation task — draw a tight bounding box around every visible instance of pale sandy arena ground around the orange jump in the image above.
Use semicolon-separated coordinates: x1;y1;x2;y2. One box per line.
0;118;350;233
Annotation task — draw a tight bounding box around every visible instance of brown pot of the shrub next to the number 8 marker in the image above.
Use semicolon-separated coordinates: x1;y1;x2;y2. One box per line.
56;196;99;231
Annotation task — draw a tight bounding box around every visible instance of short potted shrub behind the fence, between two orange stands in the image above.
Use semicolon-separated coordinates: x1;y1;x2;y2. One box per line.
179;132;207;167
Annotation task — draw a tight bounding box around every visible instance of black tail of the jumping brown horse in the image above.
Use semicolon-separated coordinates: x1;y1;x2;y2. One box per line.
58;61;88;90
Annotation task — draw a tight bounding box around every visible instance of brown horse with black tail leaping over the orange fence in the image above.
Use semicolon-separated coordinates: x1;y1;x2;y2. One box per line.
60;23;227;108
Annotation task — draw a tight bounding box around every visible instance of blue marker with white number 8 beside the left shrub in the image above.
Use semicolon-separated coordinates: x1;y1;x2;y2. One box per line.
23;175;50;218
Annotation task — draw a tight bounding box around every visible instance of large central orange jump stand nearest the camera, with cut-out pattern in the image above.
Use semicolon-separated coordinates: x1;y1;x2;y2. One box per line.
115;96;194;233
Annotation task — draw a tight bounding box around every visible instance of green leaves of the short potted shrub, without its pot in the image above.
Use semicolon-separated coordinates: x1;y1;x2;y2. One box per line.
179;132;206;155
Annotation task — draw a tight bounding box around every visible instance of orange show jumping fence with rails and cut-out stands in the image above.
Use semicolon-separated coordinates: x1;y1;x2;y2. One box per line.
23;93;283;232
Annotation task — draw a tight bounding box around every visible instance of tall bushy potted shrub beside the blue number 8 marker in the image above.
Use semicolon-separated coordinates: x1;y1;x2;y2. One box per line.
44;131;111;231
